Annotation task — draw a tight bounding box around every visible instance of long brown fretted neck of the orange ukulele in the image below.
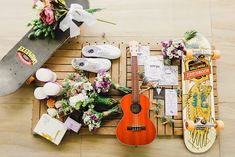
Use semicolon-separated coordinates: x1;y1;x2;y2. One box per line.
131;56;139;104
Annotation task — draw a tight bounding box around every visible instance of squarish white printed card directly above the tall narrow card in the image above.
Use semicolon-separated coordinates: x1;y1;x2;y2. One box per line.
159;66;178;86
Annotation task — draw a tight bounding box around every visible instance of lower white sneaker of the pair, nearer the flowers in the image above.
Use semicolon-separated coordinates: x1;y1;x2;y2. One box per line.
72;58;111;73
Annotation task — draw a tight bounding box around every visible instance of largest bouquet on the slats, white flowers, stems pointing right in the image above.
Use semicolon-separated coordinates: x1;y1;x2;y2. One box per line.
60;73;119;115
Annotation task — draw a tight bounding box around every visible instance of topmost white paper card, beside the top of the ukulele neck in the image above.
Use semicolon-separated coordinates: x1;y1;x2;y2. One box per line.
137;46;150;65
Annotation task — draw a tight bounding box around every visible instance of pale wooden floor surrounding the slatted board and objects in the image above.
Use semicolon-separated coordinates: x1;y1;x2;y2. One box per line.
0;0;235;157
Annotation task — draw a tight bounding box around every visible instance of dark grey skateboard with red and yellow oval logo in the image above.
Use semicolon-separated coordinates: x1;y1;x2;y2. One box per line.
0;0;89;96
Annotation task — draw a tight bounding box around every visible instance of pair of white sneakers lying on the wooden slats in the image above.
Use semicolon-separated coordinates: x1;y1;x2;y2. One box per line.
72;44;121;73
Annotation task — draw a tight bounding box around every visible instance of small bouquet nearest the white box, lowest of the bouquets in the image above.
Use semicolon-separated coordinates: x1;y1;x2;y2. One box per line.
82;105;121;133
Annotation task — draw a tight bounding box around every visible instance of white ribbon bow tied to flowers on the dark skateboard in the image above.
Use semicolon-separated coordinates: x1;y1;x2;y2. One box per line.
59;4;96;38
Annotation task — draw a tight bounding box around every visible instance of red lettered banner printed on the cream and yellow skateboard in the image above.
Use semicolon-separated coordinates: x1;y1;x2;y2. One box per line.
184;67;211;80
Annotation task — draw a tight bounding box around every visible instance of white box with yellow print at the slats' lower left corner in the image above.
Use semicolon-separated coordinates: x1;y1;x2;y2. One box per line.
34;114;67;145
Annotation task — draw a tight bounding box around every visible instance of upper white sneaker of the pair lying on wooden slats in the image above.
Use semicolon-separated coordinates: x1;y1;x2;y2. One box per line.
82;44;121;59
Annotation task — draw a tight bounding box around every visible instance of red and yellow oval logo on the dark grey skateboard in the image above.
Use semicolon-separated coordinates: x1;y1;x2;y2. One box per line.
17;46;37;65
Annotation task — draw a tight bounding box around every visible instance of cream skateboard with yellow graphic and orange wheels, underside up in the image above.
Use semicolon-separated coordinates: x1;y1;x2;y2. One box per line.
182;33;224;153
